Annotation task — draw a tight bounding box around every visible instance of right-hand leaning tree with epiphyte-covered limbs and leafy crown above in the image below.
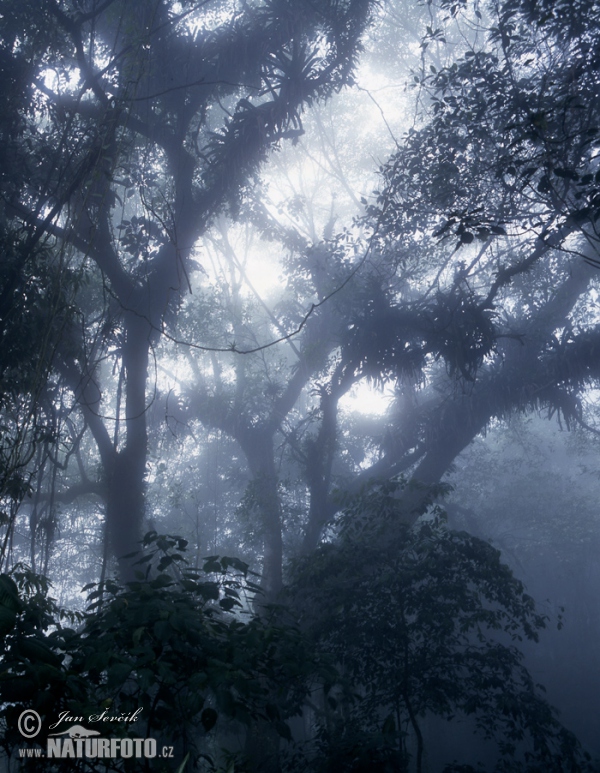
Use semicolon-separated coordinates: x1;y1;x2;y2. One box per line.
176;3;600;584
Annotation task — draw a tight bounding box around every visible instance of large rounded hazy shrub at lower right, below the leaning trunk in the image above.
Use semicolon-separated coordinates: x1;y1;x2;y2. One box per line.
290;481;579;771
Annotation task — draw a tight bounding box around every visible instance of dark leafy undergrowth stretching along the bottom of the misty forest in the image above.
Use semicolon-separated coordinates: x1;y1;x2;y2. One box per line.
0;520;587;773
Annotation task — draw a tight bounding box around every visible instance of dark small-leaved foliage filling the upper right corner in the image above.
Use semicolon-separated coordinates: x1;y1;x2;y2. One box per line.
373;0;600;253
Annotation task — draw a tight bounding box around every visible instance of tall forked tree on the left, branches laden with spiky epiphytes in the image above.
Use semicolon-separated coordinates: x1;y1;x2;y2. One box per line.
1;0;371;571
